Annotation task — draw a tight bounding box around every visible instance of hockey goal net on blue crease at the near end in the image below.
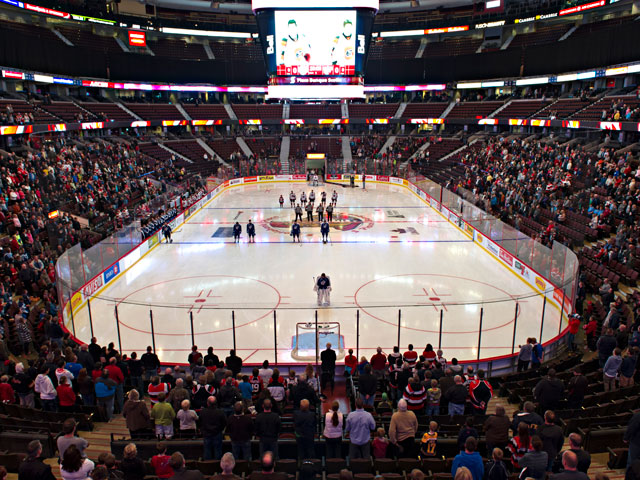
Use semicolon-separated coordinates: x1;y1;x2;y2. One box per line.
291;322;344;361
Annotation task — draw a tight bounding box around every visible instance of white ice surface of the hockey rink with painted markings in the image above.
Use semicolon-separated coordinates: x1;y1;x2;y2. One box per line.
74;183;560;364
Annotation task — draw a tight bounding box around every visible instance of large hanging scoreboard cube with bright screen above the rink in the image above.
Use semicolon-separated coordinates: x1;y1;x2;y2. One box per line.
252;0;379;98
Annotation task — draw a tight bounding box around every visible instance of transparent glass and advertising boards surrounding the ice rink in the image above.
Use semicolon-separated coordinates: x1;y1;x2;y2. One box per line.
56;174;578;375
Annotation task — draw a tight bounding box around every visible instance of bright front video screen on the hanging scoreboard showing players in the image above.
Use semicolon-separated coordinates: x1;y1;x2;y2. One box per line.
274;10;358;75
